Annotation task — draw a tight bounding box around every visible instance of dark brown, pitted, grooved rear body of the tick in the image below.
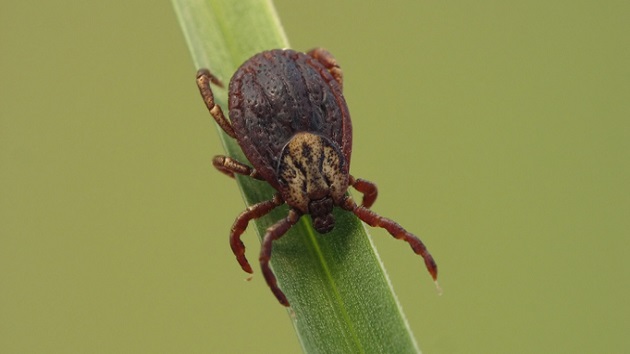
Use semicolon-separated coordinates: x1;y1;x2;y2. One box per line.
229;50;352;189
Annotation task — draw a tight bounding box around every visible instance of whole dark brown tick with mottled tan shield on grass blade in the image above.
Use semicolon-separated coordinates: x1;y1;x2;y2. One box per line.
197;48;437;306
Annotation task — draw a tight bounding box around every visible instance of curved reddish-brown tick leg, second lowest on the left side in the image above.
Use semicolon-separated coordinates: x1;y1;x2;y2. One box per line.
230;194;284;274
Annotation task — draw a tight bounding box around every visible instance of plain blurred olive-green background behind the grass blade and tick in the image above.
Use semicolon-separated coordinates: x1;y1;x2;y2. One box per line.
0;0;630;353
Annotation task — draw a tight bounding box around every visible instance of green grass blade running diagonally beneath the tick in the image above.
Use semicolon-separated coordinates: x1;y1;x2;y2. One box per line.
173;0;424;353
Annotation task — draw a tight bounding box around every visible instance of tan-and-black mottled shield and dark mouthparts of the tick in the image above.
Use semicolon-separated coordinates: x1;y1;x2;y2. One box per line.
277;132;349;233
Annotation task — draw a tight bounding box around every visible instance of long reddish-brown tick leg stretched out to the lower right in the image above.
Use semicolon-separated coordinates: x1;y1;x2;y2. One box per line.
342;197;439;289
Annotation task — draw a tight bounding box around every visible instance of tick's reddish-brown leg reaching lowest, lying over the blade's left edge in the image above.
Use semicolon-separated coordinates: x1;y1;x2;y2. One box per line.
260;209;300;307
